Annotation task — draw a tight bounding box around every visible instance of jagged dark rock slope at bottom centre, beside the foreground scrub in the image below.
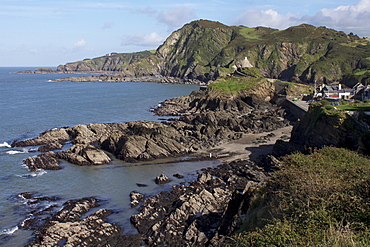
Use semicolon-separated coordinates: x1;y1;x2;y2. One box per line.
131;161;267;246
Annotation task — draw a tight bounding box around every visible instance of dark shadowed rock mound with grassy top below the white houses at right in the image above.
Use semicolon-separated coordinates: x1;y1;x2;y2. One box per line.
273;101;370;156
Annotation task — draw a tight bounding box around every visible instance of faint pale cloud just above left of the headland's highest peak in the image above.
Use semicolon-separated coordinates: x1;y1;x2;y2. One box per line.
157;8;196;31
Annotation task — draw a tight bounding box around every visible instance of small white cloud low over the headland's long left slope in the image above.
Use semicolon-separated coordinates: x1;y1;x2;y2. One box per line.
121;32;165;47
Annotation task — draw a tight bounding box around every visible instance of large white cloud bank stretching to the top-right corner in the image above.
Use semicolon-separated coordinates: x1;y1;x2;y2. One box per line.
233;0;370;36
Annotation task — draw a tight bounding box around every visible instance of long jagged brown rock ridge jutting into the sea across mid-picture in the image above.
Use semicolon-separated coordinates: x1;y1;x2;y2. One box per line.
12;80;289;169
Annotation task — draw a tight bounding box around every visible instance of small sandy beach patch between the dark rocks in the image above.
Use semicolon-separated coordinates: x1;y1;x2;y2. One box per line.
199;126;293;162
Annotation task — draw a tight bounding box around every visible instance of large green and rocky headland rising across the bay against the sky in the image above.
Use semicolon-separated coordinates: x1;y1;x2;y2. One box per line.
54;20;370;82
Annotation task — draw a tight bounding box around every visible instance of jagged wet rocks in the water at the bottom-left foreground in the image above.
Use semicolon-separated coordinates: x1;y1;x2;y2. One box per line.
27;198;122;247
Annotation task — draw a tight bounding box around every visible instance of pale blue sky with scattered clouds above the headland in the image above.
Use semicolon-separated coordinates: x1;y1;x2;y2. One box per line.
0;0;370;67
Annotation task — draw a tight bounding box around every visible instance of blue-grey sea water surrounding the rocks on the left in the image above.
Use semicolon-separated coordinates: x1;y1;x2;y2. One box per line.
0;68;219;246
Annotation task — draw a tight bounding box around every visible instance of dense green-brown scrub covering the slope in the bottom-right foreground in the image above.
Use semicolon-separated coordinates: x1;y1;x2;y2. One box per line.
232;147;370;246
